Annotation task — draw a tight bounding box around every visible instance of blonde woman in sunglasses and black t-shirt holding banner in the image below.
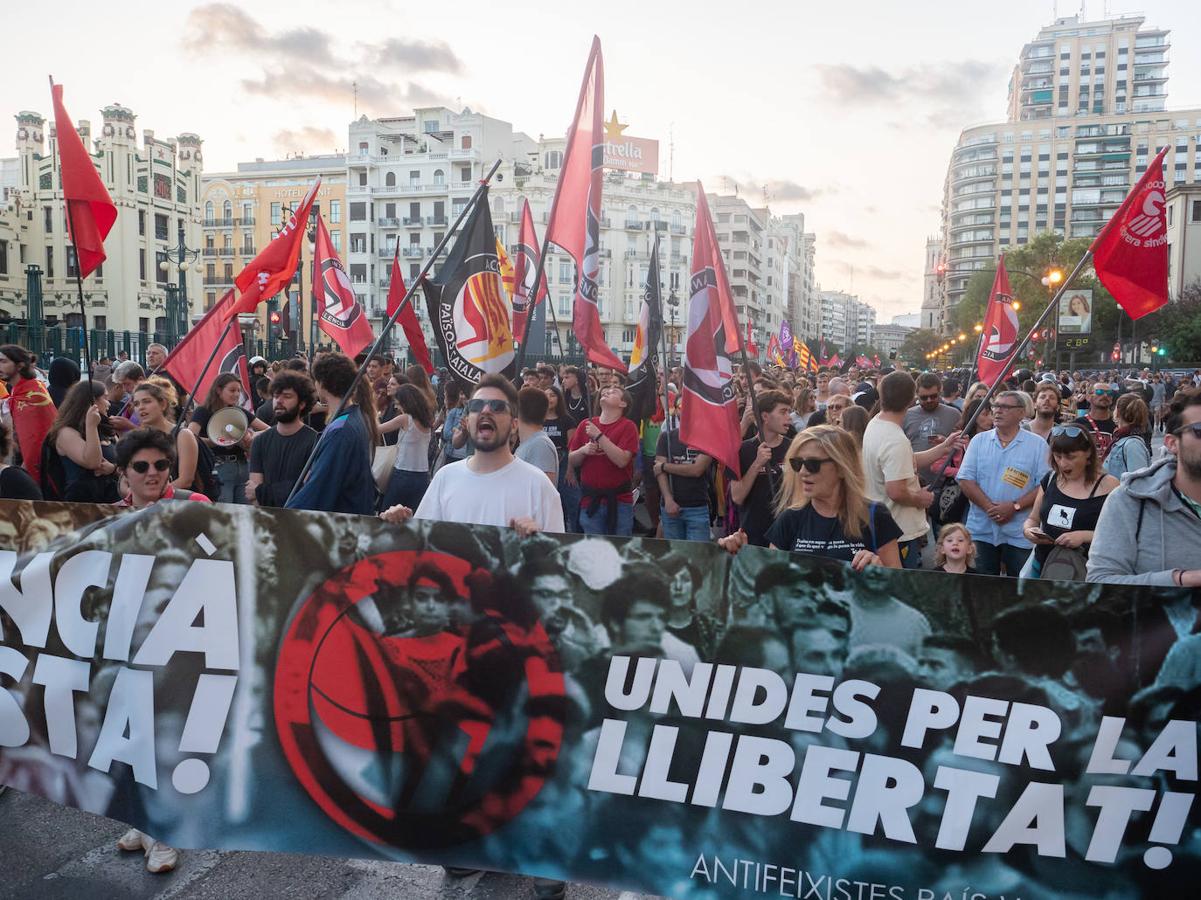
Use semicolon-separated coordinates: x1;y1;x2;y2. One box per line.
718;425;901;571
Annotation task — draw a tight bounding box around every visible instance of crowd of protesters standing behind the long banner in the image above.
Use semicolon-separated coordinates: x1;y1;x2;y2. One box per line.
0;345;1201;585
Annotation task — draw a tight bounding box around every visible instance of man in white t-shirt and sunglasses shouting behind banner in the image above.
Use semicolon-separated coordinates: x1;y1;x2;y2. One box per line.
381;375;563;537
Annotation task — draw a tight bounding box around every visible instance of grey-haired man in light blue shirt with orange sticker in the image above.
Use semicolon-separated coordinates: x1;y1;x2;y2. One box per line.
956;391;1051;578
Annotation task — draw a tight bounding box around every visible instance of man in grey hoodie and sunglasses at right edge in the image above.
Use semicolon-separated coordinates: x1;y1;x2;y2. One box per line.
1088;389;1201;586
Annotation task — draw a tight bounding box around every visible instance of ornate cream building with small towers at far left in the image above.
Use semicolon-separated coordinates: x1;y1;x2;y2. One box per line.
0;105;203;334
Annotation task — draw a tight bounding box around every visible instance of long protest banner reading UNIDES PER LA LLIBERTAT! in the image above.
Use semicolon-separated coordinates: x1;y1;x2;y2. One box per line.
0;501;1201;900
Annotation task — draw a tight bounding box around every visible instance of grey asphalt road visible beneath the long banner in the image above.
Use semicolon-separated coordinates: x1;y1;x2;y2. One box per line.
0;788;658;900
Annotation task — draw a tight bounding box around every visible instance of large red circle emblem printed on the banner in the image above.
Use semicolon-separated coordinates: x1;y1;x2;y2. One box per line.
274;550;567;850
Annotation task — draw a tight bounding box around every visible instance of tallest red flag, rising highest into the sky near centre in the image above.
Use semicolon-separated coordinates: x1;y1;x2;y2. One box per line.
546;37;627;372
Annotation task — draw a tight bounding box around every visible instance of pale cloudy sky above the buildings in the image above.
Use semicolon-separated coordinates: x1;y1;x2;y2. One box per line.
7;0;1201;321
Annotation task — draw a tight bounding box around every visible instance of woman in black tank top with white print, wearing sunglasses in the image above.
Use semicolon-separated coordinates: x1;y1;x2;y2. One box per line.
1022;424;1119;578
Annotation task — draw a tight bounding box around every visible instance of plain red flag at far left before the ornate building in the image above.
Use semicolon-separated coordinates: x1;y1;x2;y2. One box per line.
50;82;116;278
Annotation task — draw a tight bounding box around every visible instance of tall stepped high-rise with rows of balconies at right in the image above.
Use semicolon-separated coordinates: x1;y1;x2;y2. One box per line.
938;17;1201;333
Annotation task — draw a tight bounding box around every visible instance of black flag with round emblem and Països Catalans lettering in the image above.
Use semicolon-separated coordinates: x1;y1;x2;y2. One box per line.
422;187;515;392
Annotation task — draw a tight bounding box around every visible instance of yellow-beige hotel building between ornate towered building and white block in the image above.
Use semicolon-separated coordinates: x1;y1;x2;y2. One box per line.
198;154;348;346
